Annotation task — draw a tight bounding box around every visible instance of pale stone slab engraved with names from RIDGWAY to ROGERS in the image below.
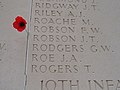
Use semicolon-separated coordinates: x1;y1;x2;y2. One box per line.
26;0;120;90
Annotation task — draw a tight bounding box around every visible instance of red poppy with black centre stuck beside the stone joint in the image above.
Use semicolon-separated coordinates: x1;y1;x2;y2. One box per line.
13;16;27;32
